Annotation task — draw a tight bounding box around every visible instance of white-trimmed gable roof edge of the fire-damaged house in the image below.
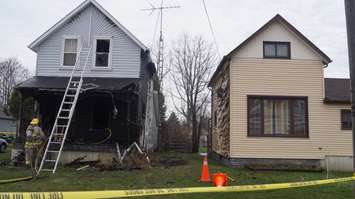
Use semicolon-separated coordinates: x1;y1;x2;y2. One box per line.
28;0;148;51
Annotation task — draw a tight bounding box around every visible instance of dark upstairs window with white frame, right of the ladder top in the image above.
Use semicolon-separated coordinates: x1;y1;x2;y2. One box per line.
95;39;111;67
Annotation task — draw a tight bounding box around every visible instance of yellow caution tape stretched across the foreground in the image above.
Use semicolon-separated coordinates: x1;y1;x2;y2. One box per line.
0;176;355;199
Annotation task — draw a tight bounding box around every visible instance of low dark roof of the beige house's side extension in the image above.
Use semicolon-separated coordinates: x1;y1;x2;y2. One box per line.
324;78;351;103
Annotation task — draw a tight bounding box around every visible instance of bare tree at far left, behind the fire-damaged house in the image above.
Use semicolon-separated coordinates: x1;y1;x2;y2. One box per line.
0;57;29;111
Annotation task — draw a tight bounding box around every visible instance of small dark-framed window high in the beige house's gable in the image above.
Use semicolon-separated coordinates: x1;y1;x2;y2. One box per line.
263;41;291;59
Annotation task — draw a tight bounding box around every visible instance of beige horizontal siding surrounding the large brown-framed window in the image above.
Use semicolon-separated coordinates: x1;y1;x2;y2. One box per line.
230;56;352;159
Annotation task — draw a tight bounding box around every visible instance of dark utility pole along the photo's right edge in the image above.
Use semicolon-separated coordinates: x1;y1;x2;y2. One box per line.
345;0;355;196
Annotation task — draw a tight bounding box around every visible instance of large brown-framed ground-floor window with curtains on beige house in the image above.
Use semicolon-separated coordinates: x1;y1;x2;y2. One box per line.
248;96;308;137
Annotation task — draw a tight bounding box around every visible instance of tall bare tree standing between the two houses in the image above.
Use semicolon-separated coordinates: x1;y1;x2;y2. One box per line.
170;33;216;152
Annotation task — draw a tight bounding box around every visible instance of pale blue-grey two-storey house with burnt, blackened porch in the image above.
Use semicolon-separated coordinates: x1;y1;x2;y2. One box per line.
15;0;158;169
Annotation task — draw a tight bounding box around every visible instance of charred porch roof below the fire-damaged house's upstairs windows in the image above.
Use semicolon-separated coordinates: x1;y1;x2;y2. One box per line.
16;76;139;91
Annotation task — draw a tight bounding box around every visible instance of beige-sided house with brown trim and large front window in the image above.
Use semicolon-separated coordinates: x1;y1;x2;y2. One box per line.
209;15;352;170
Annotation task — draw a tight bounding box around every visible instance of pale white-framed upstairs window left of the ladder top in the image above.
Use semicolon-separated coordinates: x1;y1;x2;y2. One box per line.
63;39;78;66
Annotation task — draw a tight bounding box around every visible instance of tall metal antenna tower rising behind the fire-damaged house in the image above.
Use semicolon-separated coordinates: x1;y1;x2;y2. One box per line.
141;0;180;89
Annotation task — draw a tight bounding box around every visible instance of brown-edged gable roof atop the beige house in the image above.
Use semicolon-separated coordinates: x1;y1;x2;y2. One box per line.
209;14;332;86
